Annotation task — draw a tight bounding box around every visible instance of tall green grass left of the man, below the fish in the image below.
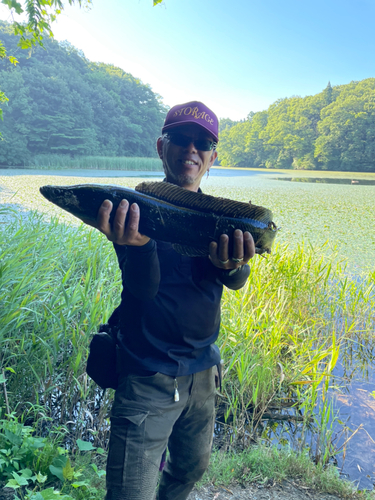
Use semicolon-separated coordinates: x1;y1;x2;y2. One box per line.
0;207;120;446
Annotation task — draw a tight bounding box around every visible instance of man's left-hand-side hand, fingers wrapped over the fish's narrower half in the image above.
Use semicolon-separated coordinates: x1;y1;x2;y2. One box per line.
86;200;150;247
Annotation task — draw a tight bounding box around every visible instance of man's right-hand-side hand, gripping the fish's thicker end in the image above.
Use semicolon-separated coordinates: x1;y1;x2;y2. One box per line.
209;229;255;269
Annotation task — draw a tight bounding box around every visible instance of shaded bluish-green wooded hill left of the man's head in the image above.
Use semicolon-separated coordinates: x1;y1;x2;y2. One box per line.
0;22;166;165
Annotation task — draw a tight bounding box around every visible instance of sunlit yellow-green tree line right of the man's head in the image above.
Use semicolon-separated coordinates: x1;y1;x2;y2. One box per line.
218;78;375;172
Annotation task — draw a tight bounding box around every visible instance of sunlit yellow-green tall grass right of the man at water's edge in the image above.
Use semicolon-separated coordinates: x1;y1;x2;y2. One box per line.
220;245;375;463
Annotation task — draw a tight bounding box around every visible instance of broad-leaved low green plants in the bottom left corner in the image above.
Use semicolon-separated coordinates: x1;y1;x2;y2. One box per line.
0;409;105;500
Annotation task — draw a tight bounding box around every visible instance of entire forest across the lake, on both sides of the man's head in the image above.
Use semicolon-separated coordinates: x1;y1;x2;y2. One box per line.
0;22;375;172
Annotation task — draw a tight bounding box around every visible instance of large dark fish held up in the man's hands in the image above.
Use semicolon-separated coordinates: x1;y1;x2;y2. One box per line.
40;182;278;257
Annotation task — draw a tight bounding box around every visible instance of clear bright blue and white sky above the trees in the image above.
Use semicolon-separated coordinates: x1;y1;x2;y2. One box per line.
0;0;375;120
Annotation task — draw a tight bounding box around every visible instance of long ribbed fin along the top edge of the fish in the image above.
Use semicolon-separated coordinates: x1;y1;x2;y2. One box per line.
135;182;272;224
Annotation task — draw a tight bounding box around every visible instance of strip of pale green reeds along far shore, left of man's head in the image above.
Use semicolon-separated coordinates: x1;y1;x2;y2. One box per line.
24;155;163;172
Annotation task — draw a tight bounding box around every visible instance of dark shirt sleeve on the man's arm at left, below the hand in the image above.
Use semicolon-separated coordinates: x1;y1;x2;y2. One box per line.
113;240;160;300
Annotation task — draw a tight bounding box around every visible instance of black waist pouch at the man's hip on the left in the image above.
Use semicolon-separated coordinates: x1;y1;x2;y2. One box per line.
86;324;118;389
